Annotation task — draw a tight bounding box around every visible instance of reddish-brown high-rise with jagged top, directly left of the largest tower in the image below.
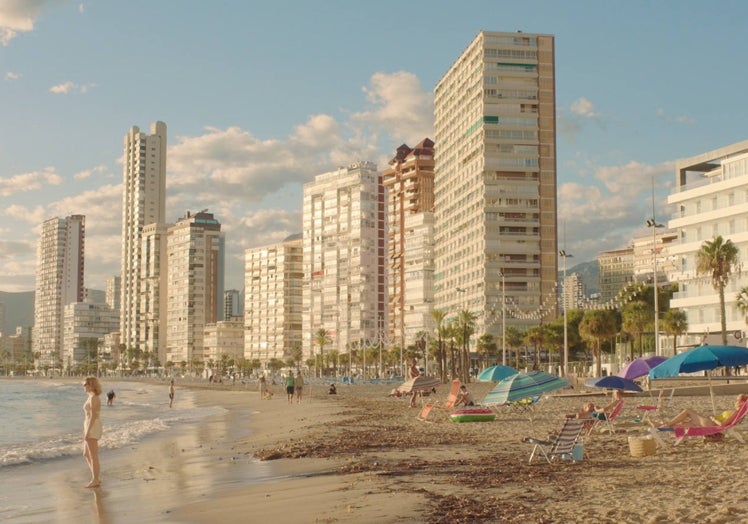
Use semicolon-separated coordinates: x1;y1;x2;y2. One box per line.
382;138;434;348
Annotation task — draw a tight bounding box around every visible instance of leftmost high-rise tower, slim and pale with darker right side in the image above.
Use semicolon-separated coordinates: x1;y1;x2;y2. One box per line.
32;215;86;368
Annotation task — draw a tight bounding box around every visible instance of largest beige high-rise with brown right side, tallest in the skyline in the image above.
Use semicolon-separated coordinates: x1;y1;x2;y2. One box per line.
434;31;558;337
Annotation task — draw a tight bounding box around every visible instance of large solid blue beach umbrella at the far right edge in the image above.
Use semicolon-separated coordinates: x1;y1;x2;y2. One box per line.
649;345;748;378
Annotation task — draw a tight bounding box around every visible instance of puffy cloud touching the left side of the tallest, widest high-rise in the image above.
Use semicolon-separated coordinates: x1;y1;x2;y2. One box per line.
351;71;434;145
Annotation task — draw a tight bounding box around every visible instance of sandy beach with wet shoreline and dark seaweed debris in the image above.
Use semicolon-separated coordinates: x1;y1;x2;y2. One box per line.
8;376;748;523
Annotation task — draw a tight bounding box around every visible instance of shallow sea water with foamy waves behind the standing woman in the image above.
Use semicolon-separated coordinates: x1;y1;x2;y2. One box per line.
0;378;225;471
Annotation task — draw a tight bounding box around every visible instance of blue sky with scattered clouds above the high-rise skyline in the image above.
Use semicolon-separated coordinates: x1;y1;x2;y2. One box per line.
0;0;748;292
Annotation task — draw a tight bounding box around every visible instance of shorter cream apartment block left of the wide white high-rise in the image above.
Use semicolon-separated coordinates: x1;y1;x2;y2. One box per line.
244;234;304;365
